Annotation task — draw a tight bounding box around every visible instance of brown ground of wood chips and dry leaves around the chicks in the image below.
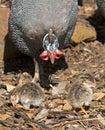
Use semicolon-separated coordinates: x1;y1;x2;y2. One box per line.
0;2;105;130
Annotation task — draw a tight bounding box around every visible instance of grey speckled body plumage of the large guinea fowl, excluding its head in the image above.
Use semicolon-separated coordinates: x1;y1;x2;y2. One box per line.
9;0;77;56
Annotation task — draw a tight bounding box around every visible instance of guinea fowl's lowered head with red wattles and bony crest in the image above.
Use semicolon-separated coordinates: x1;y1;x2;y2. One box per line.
40;29;63;64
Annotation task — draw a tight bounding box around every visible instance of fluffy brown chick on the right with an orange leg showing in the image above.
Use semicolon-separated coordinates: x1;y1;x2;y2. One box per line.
67;74;95;114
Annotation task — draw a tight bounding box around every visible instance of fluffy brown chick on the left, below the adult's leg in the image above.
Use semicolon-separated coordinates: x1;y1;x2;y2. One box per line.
10;82;45;109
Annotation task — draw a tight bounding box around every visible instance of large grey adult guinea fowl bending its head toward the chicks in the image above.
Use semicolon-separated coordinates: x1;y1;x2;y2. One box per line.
9;0;78;81
